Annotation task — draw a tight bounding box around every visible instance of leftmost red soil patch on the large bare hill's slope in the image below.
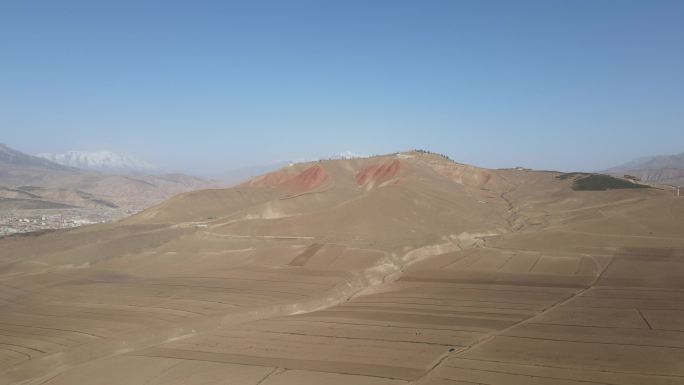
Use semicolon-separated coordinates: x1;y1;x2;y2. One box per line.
245;165;330;194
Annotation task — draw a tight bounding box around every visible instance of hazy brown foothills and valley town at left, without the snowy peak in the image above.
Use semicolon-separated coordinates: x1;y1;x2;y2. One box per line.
0;143;223;236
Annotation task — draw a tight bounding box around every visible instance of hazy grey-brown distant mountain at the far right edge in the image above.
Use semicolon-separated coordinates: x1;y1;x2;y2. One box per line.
604;152;684;185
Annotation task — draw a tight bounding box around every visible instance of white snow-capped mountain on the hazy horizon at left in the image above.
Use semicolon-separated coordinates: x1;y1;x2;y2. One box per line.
36;150;157;173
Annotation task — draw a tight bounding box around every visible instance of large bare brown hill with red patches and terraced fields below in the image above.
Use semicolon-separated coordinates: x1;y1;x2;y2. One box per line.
0;152;684;385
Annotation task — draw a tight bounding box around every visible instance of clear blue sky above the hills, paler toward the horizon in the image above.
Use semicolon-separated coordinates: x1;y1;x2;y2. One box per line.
0;0;684;175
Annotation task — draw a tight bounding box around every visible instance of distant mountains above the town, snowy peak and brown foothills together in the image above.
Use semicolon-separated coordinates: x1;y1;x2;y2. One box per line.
0;144;224;210
